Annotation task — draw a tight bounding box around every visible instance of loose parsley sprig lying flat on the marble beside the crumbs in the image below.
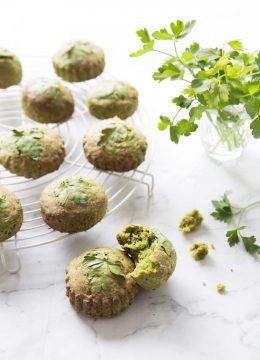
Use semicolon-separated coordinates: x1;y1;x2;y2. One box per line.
211;194;260;255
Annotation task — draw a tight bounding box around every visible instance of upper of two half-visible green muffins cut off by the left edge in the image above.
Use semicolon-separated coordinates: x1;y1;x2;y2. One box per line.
0;48;22;89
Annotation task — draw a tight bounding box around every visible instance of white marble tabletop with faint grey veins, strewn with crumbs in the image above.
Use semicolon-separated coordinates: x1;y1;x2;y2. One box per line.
0;1;260;360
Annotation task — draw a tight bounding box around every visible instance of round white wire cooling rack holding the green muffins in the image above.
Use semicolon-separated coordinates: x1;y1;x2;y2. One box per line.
0;58;154;273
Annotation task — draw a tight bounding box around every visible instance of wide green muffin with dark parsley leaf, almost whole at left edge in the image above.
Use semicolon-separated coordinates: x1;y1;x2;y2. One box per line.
0;125;65;179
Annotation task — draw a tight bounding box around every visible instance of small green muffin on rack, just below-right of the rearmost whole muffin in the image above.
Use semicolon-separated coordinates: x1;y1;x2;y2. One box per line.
87;80;138;119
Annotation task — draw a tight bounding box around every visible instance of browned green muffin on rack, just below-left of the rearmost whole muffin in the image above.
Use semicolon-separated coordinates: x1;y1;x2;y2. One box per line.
21;77;74;123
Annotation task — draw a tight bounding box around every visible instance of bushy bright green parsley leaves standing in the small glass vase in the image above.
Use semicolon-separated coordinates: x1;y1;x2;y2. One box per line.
130;20;260;144
